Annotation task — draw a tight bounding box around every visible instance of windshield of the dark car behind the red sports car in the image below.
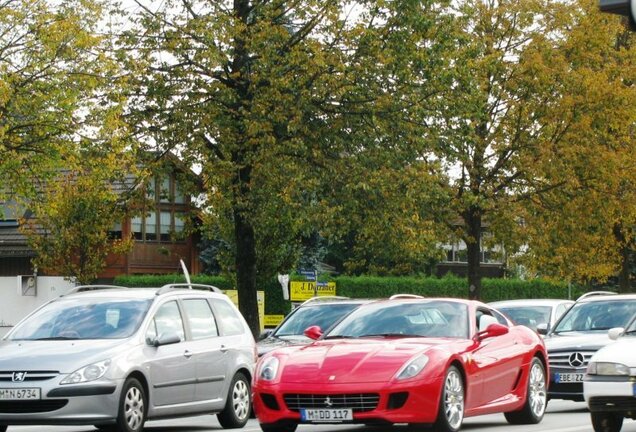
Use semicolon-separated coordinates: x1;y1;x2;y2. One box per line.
274;303;360;337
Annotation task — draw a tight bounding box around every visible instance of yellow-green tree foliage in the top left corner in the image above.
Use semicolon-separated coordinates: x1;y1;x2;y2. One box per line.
0;0;121;196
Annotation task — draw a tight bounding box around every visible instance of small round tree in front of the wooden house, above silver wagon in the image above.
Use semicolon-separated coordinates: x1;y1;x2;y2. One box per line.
23;172;133;285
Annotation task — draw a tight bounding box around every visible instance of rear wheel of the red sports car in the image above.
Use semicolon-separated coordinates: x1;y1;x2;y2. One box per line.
504;357;548;424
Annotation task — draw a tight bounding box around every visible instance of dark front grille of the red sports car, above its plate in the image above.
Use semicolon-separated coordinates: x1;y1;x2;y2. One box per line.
283;393;380;412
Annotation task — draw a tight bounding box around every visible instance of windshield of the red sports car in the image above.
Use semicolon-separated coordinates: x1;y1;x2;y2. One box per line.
325;300;468;338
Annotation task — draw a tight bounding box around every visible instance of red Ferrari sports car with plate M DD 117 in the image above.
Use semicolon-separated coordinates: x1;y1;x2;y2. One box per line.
253;298;549;432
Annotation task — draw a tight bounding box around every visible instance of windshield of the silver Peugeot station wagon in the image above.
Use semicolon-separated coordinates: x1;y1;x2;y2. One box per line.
8;298;152;340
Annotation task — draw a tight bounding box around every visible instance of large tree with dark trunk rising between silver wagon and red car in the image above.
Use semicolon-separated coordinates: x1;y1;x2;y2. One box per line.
120;0;458;334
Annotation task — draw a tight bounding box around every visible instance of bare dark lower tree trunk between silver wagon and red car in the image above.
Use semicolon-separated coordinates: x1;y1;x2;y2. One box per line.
234;209;261;338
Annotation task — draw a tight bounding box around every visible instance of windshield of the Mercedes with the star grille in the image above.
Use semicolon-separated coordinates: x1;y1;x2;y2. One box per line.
554;300;636;333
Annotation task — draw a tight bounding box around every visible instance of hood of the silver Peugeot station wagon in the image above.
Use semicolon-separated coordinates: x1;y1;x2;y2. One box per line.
0;339;127;373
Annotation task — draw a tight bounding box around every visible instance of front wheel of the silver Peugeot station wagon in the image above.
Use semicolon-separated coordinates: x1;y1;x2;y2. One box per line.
115;378;148;432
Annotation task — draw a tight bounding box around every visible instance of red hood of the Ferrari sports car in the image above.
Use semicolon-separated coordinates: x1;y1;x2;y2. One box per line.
274;338;448;384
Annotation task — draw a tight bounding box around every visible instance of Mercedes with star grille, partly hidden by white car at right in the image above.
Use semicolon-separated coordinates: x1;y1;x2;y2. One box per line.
545;294;636;402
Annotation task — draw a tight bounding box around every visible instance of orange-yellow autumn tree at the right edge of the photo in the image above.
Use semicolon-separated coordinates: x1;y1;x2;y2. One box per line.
522;0;636;292
